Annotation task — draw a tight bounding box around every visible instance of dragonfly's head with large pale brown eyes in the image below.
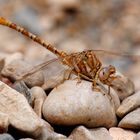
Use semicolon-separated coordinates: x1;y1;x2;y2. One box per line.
99;65;116;85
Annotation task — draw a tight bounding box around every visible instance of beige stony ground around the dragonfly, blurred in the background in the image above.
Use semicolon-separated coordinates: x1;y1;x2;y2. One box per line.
0;0;140;140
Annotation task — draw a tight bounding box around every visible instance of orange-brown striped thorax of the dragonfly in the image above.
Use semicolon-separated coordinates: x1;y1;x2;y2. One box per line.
63;50;102;79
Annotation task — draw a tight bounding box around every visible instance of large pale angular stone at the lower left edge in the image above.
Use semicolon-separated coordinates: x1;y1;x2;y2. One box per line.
0;82;43;136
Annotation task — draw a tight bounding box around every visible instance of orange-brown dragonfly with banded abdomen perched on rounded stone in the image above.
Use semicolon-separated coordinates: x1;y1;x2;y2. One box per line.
0;17;138;92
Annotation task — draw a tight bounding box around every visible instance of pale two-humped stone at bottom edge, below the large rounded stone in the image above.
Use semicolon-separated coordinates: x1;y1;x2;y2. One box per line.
69;126;112;140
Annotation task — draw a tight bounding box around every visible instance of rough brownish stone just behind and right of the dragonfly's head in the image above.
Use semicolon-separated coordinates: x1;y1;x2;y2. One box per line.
111;75;135;101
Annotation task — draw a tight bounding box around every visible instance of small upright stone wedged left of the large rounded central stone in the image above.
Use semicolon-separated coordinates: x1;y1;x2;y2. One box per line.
31;86;47;118
